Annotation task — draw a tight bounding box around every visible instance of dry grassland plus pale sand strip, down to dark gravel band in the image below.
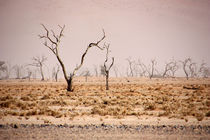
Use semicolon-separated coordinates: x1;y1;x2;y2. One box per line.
0;77;210;139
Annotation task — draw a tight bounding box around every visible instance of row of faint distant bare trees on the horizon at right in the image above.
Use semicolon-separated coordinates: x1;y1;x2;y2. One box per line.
126;57;210;80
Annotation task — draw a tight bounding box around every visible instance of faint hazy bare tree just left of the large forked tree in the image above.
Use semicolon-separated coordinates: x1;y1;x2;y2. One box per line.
28;56;47;81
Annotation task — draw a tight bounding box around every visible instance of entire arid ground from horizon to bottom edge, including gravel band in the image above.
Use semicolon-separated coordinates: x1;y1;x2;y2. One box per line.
0;77;210;139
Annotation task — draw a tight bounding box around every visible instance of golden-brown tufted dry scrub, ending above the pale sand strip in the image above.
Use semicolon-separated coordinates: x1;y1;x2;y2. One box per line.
0;80;210;121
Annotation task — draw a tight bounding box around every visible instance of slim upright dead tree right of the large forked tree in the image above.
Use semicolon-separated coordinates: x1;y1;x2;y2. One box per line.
104;44;114;90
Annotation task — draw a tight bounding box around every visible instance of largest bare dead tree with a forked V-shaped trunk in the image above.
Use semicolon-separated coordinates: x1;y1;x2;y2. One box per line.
39;24;105;92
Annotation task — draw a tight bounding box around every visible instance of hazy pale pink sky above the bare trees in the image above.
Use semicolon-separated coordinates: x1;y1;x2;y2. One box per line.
0;0;210;76
